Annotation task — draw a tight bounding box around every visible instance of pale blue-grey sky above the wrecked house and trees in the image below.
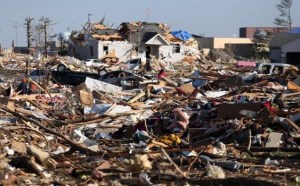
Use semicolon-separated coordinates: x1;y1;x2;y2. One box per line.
0;0;300;48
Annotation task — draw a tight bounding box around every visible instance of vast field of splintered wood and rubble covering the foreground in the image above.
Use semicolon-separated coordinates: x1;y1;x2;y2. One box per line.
0;49;300;185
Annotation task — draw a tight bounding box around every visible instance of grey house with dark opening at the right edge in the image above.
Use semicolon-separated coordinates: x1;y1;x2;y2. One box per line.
269;32;300;66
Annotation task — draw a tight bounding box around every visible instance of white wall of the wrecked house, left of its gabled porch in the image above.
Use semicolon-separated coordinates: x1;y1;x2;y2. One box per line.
98;41;135;61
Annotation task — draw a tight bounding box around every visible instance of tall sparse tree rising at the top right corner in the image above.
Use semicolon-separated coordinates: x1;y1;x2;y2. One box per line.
274;0;293;31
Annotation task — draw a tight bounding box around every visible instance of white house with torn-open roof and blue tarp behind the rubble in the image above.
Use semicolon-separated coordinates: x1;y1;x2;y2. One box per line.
70;22;200;62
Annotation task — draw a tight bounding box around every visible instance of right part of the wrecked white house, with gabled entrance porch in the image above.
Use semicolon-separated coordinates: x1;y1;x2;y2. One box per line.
120;22;199;62
